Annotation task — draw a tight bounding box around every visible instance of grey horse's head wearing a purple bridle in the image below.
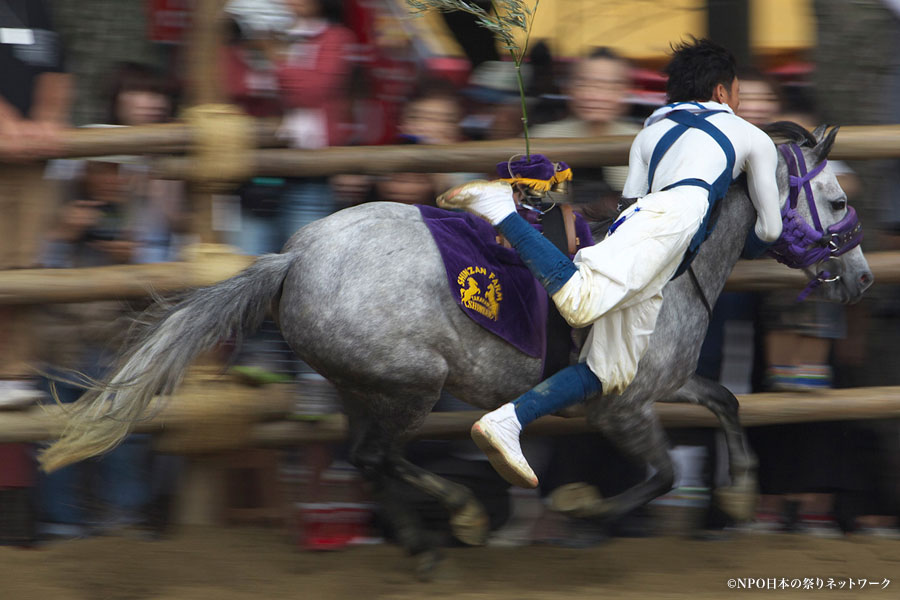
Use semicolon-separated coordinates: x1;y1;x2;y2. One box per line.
766;121;874;303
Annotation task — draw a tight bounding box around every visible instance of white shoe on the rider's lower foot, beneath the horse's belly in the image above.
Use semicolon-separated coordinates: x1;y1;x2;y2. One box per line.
472;403;538;488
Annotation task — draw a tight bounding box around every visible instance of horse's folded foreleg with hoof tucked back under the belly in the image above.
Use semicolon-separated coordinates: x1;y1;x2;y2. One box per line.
551;407;675;520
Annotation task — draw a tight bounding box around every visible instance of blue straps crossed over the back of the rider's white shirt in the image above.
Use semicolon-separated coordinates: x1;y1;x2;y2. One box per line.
648;110;735;277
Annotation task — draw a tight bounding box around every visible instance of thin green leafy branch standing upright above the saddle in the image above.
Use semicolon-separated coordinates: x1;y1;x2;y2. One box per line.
406;0;540;159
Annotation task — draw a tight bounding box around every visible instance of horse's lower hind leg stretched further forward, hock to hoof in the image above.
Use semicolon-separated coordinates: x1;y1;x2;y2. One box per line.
391;457;490;546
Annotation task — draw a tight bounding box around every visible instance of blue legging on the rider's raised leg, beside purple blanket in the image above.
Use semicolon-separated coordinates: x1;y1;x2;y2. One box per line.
496;213;578;296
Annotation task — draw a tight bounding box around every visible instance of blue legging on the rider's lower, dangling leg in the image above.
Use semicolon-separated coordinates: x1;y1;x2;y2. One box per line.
504;360;603;427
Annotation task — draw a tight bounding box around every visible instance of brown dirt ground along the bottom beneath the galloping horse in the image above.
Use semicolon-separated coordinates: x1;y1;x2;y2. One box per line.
0;528;900;600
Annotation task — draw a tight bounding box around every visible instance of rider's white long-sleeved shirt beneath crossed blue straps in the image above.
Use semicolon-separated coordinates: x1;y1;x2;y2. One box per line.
622;102;781;242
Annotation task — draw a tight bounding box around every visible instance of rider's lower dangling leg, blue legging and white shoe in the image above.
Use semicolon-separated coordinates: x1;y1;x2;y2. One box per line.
472;363;603;488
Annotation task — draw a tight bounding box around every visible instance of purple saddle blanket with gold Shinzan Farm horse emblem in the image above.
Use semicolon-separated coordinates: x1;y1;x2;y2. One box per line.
418;205;592;359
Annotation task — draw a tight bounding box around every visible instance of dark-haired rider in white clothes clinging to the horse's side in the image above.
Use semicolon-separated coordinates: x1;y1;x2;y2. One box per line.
438;38;781;487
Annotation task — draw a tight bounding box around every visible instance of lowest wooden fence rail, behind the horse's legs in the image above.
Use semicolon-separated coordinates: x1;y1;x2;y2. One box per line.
0;384;900;452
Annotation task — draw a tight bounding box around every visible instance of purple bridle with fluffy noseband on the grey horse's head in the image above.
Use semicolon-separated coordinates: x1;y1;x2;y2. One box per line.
769;143;863;301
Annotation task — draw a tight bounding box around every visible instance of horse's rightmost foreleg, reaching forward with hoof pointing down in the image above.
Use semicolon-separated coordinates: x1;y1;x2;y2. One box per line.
666;375;757;521
